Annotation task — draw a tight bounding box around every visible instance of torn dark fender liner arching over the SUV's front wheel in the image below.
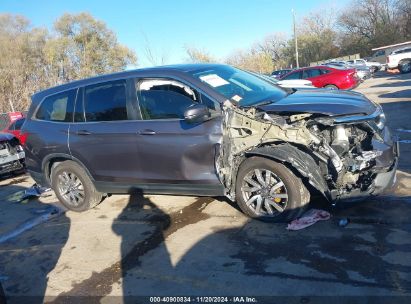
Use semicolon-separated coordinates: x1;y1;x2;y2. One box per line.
246;143;331;201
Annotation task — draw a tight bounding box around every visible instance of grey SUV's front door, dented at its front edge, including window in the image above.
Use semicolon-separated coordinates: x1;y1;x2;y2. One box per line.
135;78;222;189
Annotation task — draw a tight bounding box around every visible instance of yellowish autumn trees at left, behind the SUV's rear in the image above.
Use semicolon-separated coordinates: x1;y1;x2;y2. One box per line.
0;13;137;113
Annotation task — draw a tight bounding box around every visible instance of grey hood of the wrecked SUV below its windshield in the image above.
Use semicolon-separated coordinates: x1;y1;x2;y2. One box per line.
257;89;377;116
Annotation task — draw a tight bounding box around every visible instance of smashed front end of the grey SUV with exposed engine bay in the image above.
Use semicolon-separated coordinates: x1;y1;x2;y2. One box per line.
217;101;398;201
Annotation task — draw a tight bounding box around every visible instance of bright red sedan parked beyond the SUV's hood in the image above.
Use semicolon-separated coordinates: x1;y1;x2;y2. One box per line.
280;66;360;90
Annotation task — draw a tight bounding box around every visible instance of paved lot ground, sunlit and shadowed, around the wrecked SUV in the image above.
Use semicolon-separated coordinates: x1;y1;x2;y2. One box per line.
0;72;411;303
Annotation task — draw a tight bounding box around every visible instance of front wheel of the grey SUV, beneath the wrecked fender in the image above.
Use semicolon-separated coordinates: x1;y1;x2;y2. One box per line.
236;157;310;222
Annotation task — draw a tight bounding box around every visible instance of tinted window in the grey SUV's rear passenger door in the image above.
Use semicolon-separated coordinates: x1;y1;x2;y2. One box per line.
84;80;127;121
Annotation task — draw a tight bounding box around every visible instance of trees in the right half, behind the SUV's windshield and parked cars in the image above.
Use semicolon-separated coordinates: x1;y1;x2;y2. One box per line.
186;0;411;74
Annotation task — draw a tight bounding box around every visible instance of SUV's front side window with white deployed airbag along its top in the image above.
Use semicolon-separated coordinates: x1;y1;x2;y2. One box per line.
136;79;199;120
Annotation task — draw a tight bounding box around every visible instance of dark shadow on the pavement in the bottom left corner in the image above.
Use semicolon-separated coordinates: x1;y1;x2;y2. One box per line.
0;183;70;303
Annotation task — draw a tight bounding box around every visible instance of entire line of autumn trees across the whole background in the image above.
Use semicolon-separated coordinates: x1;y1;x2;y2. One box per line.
0;0;411;113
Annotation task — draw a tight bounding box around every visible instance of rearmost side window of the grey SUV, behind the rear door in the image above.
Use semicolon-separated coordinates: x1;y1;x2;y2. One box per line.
35;89;77;122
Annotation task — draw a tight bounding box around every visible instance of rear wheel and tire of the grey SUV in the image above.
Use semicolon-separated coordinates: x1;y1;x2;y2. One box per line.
51;160;103;212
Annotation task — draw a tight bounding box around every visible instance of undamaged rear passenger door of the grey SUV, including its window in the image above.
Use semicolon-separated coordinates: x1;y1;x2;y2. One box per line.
69;79;140;184
